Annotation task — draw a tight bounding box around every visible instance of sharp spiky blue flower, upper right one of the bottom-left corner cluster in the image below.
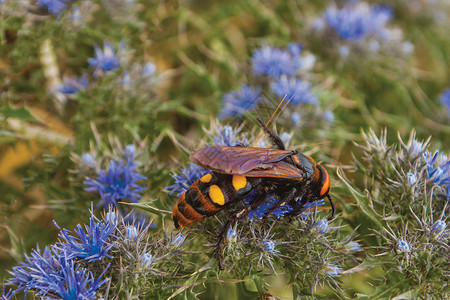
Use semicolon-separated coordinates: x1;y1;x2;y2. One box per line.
54;210;117;262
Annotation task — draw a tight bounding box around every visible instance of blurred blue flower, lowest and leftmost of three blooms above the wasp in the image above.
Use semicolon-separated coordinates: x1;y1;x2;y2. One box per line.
219;85;262;119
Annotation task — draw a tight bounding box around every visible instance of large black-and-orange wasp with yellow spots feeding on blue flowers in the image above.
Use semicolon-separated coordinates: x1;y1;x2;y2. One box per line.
172;119;335;233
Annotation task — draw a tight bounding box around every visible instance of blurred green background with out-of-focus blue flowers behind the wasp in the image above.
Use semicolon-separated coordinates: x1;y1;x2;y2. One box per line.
0;0;450;299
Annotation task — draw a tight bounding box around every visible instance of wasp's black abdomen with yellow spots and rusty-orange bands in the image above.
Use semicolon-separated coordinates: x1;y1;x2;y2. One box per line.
172;172;253;228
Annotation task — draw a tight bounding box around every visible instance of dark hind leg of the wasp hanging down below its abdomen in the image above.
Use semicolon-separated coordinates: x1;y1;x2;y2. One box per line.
214;192;267;270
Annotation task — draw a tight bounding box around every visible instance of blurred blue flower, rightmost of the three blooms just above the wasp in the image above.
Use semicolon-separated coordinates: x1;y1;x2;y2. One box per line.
271;76;318;105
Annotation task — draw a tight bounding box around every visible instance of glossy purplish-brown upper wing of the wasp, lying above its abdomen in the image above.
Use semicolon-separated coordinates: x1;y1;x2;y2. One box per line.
190;146;296;175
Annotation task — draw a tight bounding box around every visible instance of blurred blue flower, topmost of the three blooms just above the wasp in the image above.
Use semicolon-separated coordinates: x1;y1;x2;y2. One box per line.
251;45;301;78
